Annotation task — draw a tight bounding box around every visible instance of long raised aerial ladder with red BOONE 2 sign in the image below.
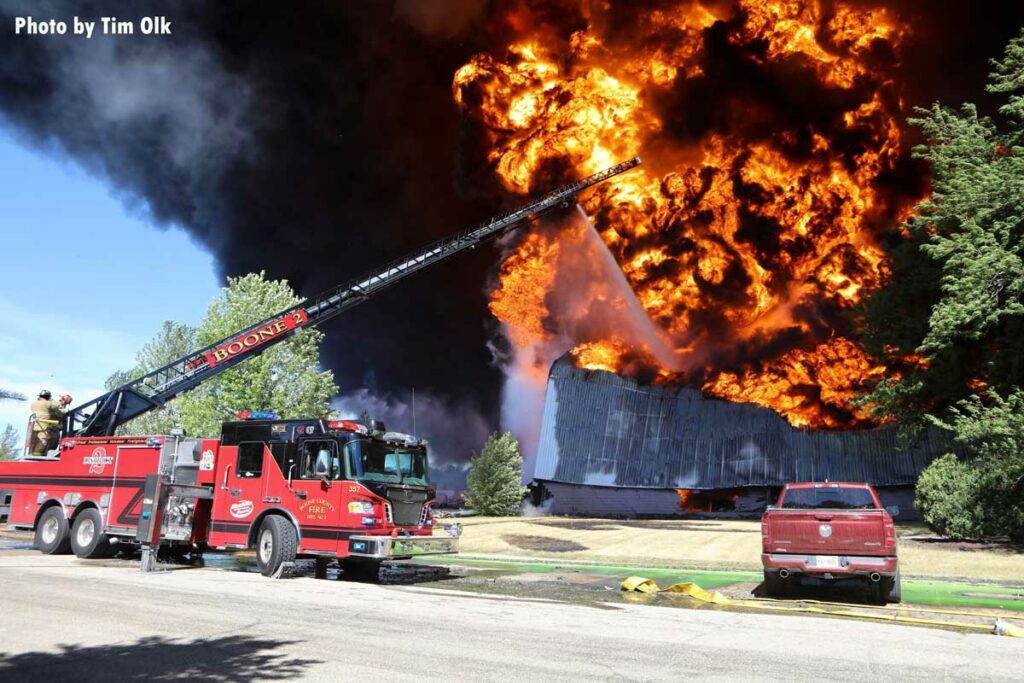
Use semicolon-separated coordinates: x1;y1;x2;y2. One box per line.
61;157;641;438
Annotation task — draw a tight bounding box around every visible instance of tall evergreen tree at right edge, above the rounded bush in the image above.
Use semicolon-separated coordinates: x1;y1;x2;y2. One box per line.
862;32;1024;418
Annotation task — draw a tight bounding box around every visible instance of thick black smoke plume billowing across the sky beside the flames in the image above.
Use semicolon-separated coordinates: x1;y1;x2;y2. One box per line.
0;0;1024;458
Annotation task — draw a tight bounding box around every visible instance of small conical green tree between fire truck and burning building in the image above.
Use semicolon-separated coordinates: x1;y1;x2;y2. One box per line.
466;432;526;516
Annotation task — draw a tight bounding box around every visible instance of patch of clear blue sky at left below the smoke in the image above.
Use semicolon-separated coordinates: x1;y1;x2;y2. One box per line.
0;127;221;430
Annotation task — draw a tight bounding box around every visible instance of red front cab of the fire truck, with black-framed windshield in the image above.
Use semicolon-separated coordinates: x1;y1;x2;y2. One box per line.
207;414;448;575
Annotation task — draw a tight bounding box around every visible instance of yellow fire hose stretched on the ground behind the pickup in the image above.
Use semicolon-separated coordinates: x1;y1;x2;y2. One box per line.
621;577;1024;638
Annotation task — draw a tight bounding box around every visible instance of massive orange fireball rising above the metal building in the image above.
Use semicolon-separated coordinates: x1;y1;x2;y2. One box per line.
453;0;916;428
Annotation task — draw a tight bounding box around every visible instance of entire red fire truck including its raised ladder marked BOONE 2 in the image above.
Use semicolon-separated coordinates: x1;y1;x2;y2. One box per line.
0;158;640;577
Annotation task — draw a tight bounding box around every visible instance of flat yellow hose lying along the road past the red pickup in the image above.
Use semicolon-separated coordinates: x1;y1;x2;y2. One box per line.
621;577;1024;638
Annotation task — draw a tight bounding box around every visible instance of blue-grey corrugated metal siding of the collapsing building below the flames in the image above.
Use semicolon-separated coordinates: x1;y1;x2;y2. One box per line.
532;361;950;489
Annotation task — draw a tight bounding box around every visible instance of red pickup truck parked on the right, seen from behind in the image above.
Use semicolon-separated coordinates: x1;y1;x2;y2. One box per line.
761;482;900;604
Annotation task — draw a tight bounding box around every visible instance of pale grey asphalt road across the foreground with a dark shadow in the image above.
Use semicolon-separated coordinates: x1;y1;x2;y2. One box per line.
0;551;1024;681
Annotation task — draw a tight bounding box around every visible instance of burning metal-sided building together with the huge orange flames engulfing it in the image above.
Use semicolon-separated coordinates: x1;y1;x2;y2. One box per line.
453;0;966;513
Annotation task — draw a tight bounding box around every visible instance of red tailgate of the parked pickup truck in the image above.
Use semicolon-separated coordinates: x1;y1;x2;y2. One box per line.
763;510;892;555
